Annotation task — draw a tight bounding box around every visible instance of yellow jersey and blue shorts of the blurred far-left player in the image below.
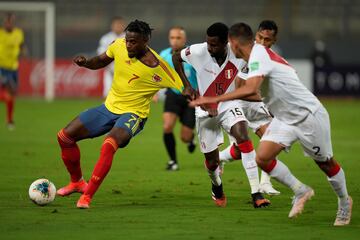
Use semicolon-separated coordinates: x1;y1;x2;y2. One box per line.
0;28;24;86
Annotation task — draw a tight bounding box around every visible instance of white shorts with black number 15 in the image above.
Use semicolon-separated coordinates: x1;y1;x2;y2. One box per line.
196;101;247;153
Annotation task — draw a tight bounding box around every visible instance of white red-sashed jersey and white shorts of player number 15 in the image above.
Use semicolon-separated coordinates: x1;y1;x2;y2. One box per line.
181;43;247;153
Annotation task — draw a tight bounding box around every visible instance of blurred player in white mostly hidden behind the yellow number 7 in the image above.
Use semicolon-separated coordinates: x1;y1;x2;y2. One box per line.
97;17;126;97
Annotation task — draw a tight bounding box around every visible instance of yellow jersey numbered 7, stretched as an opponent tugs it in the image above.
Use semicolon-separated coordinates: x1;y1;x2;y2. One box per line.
105;38;183;118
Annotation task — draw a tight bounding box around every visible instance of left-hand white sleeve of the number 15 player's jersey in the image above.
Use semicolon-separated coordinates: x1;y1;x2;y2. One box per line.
180;43;207;69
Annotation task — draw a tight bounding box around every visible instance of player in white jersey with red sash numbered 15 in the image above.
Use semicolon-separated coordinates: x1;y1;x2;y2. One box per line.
173;23;270;208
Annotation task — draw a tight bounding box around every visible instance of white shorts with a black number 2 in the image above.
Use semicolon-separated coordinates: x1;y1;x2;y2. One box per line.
261;107;333;162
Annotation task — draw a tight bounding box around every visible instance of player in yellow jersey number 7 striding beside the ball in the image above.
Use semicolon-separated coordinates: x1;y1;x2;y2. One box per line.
57;20;195;208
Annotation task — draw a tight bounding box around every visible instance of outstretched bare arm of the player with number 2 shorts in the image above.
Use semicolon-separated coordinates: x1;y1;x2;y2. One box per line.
190;76;264;106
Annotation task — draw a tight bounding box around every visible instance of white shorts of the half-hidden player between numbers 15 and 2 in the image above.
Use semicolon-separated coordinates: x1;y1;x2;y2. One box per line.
241;101;272;133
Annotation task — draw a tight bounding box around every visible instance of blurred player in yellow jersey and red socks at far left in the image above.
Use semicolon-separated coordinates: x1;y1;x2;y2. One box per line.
0;13;24;130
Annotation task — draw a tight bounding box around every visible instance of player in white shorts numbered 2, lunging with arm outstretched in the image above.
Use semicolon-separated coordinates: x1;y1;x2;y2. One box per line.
192;23;353;226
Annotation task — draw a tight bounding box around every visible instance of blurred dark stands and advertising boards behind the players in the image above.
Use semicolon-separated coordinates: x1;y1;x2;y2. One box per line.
1;0;360;97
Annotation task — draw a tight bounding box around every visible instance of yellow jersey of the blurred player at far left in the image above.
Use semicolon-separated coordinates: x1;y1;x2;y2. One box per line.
0;28;24;71
